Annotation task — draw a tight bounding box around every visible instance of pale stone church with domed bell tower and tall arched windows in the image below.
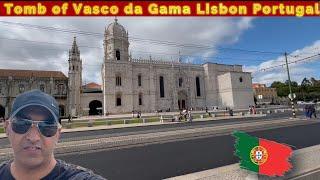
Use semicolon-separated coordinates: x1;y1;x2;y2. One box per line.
102;20;253;114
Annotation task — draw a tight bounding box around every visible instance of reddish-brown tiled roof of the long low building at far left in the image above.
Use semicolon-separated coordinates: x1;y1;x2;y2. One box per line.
0;69;68;79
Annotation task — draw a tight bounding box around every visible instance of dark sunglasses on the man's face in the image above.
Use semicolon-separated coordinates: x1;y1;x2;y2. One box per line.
11;117;60;137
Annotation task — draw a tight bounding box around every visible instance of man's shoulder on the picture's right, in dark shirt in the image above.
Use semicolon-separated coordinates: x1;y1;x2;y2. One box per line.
57;159;105;180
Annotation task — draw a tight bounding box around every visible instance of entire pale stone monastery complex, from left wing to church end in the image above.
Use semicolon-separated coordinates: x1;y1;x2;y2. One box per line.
0;20;254;116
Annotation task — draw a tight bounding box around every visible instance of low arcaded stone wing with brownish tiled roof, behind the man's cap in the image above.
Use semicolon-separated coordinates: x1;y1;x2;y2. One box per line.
0;69;68;117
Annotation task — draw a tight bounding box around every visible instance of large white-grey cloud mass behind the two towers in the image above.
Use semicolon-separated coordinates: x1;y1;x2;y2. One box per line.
0;17;252;83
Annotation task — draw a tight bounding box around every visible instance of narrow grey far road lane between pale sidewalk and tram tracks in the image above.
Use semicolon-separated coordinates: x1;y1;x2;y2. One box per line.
0;112;300;147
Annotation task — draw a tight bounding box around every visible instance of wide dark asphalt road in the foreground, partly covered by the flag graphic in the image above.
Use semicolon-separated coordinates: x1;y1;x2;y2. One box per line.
59;117;320;180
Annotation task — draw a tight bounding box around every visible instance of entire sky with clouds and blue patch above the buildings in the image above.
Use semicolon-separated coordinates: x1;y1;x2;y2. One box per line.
0;17;320;85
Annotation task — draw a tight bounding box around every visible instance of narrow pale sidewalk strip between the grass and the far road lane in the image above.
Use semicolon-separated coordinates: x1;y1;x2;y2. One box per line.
0;114;266;138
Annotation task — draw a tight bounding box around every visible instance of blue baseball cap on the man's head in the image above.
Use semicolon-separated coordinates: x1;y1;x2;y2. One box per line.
10;90;59;123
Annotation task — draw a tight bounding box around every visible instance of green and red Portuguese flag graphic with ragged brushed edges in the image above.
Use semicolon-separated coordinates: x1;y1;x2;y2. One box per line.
233;131;292;176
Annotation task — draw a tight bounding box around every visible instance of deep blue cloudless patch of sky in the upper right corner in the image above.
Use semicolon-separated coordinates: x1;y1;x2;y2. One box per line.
232;17;320;52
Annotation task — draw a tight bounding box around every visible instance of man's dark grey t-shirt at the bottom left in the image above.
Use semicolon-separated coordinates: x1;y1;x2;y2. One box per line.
0;159;105;180
